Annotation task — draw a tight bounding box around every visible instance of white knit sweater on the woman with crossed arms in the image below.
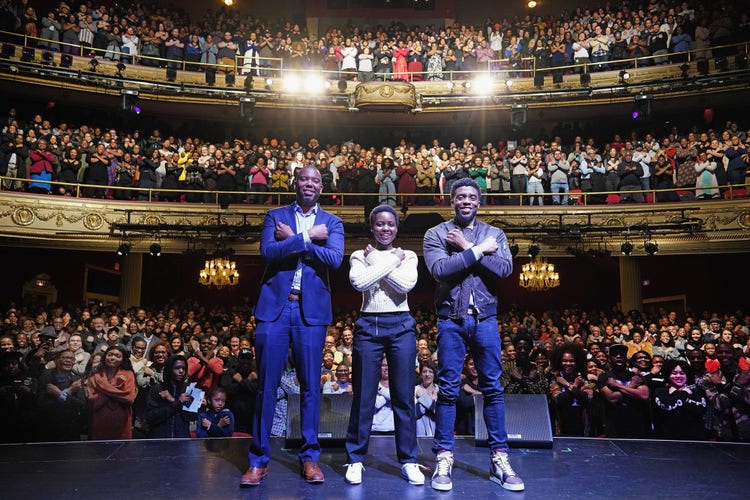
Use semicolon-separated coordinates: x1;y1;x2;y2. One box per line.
349;250;417;313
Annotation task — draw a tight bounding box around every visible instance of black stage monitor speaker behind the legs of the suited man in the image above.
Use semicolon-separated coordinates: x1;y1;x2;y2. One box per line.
286;392;352;447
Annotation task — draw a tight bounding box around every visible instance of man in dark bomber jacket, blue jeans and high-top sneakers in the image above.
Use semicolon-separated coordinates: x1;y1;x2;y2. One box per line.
424;178;524;491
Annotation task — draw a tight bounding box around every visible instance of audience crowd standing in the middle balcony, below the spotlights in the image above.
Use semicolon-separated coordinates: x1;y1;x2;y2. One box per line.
0;105;750;207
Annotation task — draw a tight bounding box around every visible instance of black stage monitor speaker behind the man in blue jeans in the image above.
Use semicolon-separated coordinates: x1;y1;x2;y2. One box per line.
474;394;552;448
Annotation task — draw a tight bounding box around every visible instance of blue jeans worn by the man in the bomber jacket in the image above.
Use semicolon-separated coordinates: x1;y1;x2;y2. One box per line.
432;315;508;453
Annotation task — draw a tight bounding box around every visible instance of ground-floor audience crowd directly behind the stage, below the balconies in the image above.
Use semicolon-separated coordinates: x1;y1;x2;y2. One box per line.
0;294;750;442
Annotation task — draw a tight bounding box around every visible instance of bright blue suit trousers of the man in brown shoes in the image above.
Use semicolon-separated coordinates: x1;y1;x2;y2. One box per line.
248;297;326;467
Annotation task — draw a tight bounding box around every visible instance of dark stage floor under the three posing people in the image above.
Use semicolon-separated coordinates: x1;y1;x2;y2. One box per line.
0;436;750;500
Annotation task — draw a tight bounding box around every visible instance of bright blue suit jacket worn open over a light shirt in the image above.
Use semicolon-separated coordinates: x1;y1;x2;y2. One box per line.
255;205;344;326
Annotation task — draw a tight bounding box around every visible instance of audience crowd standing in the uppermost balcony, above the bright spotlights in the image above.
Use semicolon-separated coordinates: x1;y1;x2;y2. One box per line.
0;0;750;82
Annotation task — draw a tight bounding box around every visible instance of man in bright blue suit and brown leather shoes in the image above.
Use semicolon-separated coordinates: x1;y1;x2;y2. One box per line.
240;166;344;487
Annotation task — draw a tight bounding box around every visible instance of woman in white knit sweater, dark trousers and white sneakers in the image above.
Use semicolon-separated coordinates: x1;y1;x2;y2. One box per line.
345;205;424;485
